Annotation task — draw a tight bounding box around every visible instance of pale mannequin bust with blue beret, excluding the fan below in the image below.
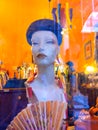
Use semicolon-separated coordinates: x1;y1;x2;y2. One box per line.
26;19;67;108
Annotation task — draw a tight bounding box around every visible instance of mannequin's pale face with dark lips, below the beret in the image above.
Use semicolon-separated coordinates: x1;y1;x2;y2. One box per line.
31;31;59;65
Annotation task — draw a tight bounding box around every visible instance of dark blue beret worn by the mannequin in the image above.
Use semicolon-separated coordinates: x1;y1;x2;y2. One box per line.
26;19;62;45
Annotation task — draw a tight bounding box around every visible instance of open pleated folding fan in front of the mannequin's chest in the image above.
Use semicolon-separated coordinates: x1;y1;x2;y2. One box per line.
6;101;66;130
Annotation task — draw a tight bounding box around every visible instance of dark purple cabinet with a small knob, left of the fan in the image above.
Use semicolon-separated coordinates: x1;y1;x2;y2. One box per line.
0;88;28;130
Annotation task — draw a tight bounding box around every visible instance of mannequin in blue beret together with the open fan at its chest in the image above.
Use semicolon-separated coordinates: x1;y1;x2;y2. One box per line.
5;19;67;130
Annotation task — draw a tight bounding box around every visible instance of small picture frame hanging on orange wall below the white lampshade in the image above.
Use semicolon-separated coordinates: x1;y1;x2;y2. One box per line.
84;40;92;59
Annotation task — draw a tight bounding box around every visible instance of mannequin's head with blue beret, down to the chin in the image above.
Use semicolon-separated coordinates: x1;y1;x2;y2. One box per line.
26;19;62;65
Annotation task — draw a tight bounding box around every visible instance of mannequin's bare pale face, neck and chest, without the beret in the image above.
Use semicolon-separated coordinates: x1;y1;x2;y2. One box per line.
30;31;65;101
